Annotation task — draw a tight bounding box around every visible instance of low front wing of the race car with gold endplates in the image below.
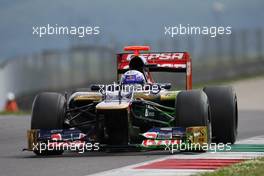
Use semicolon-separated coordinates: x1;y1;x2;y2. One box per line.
24;126;210;152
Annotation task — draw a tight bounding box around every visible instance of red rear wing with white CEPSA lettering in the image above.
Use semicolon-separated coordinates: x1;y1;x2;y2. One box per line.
117;52;192;89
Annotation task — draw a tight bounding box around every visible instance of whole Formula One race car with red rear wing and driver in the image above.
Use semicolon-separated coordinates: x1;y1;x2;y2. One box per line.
27;46;238;155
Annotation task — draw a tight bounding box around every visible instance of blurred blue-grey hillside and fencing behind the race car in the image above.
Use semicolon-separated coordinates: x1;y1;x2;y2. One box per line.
0;0;264;110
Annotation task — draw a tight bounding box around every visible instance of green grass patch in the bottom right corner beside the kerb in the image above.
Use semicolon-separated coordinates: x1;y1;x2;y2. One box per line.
198;157;264;176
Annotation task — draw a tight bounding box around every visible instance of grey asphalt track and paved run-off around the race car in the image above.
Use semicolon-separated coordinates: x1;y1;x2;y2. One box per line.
0;77;264;176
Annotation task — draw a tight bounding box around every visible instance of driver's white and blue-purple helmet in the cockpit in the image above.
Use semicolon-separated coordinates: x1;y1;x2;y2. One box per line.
120;70;146;84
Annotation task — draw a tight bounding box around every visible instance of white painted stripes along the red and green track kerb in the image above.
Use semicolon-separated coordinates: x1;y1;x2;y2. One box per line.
85;135;264;176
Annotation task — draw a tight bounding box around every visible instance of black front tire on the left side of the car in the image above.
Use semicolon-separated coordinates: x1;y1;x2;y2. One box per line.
31;92;66;155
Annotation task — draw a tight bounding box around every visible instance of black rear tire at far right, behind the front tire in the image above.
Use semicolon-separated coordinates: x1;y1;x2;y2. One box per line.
203;86;238;144
